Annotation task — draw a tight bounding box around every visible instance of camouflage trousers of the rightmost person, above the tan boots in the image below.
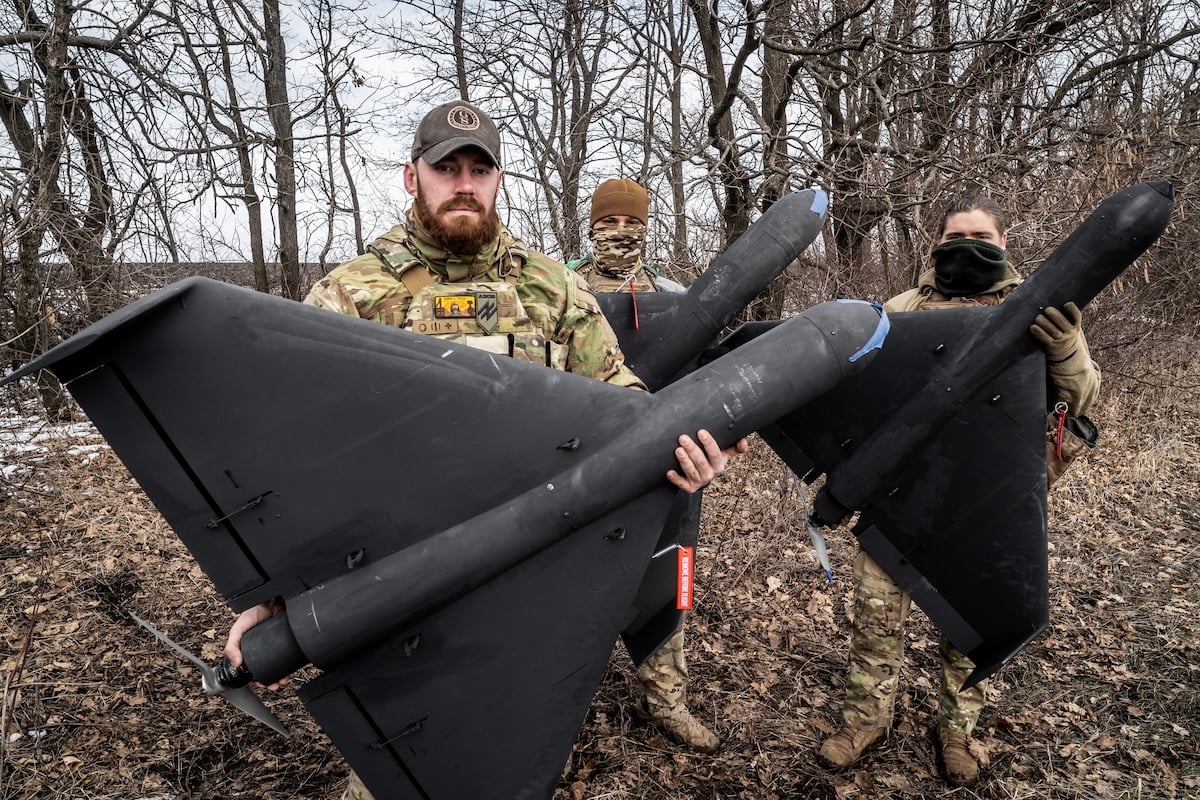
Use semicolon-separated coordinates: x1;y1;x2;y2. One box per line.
842;549;986;735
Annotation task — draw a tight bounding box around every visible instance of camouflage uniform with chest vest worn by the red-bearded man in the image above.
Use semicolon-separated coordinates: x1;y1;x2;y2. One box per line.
321;210;646;800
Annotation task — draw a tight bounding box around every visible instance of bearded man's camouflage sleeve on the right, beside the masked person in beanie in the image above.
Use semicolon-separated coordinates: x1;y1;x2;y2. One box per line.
559;272;646;390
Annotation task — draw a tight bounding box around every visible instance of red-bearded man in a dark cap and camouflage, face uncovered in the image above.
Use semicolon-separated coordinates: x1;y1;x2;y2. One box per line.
226;101;745;800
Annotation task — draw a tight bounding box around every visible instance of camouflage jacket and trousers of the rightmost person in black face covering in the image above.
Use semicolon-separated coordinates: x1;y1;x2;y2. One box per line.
842;265;1100;741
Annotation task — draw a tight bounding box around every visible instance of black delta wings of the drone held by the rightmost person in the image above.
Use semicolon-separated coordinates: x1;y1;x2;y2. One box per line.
739;309;1049;680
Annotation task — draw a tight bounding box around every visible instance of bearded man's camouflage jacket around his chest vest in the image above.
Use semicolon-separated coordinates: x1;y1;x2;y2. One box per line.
305;211;644;389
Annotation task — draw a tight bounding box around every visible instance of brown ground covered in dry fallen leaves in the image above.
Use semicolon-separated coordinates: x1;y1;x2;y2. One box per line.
0;344;1200;800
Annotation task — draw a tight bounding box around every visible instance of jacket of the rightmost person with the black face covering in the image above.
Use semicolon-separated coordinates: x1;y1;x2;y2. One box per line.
883;265;1100;416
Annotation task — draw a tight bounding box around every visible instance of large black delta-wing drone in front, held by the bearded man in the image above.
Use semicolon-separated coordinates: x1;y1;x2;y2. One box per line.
8;278;880;798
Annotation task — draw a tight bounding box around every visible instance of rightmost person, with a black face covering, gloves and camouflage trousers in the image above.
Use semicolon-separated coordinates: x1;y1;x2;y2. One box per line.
820;196;1100;786
